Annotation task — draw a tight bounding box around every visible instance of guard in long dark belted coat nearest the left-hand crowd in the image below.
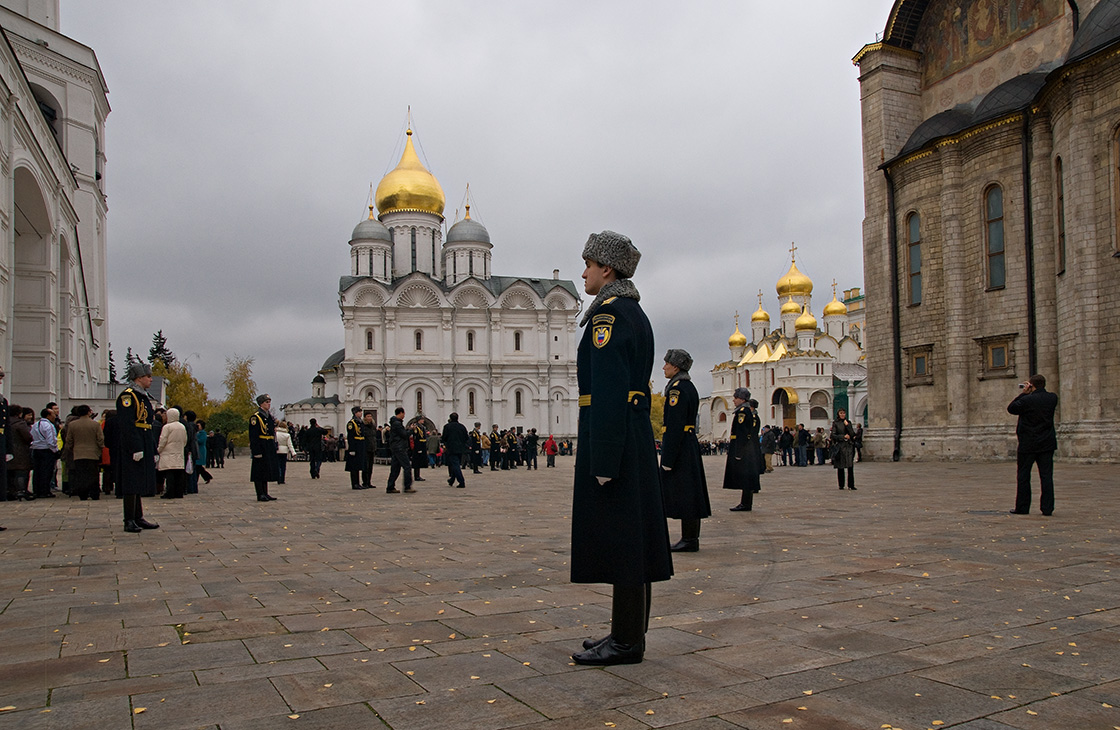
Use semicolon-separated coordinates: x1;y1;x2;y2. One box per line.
110;363;159;532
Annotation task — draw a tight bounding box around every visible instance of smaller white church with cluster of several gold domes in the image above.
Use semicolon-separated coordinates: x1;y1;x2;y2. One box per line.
700;246;867;441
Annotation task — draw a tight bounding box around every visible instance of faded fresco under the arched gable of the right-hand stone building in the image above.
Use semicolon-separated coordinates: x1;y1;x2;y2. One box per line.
914;0;1065;86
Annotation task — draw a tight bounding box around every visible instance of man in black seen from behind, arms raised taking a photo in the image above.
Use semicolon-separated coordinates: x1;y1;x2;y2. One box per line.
1007;375;1057;516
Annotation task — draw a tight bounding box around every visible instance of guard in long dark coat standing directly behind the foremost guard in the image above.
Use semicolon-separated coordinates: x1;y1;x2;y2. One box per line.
661;349;711;553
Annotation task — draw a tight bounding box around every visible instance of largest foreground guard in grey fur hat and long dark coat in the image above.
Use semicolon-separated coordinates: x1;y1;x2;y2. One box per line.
571;231;673;665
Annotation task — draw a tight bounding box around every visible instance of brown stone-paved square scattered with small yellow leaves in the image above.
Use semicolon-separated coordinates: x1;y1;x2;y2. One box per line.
0;458;1120;730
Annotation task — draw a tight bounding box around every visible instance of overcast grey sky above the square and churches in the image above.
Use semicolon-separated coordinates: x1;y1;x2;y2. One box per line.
62;0;892;404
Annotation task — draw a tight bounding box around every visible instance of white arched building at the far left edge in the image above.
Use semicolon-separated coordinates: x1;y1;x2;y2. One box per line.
0;0;114;410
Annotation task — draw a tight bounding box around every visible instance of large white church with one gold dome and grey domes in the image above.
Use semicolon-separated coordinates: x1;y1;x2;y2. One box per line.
284;129;581;437
